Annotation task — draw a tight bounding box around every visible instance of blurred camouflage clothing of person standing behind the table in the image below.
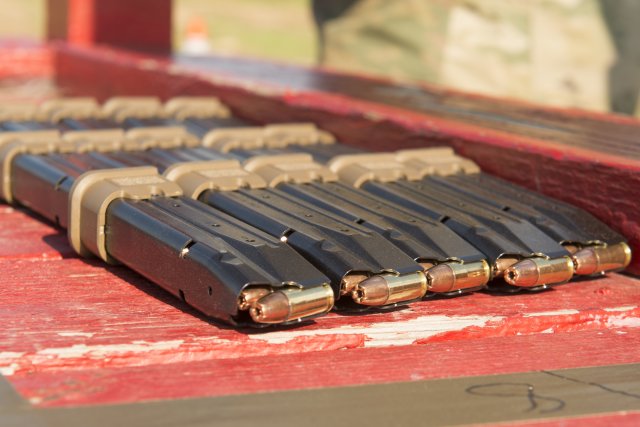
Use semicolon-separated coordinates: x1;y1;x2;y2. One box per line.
314;0;624;111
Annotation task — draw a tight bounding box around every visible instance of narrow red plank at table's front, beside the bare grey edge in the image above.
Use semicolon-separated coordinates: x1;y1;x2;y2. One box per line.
8;328;640;407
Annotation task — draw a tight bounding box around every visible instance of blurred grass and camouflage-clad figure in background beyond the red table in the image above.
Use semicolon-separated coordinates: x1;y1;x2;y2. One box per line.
0;0;640;116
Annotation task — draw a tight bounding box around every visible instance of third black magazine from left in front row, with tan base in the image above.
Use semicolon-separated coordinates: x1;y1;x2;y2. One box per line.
244;155;491;293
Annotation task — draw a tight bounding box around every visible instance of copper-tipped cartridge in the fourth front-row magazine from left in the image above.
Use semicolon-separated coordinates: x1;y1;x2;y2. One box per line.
504;257;573;288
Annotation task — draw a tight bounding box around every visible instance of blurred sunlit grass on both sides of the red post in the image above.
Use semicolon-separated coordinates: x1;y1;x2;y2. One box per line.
0;0;316;65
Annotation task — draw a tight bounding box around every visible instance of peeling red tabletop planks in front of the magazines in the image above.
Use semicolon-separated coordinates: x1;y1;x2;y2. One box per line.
0;237;640;405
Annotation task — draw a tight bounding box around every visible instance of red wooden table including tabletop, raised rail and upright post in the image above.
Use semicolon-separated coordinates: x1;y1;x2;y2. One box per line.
0;0;640;426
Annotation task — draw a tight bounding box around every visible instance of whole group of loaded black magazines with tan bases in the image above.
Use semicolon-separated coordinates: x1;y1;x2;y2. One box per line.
0;97;631;327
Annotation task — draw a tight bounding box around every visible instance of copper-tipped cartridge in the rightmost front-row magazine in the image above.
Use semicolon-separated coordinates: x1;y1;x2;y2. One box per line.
571;242;631;275
